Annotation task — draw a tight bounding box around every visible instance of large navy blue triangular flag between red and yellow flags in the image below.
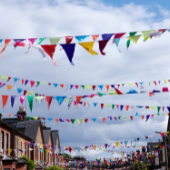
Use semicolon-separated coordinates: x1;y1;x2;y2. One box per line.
60;44;75;65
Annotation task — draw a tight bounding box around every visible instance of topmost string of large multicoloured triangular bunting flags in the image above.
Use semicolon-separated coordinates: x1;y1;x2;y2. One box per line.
0;29;170;66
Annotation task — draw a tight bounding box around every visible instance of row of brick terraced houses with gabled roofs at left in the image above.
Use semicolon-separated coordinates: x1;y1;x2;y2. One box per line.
0;107;60;170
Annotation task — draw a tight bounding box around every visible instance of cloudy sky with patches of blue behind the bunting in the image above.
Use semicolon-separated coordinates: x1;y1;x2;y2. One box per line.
0;0;170;157
